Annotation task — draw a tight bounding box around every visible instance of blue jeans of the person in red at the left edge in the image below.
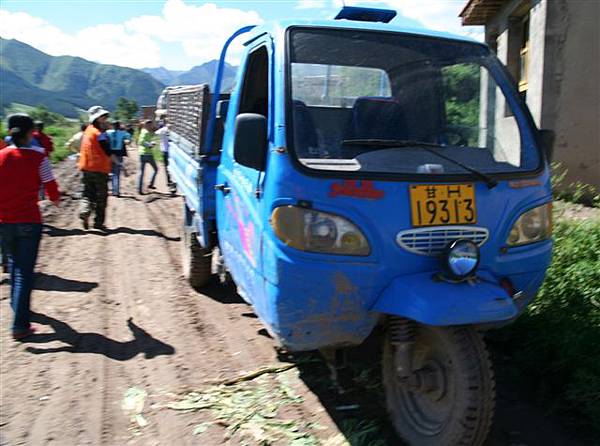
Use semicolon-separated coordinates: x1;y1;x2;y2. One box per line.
0;223;42;331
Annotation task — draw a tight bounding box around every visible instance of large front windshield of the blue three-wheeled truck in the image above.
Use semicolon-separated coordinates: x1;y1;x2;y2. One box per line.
289;28;540;178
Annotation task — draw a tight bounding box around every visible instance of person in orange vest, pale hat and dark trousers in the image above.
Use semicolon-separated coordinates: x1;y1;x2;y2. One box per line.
78;105;112;231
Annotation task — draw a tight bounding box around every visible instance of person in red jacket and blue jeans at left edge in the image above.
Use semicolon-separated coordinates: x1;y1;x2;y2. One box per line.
0;113;60;340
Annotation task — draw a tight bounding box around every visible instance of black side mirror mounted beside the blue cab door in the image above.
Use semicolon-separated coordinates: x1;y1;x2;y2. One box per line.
233;113;267;171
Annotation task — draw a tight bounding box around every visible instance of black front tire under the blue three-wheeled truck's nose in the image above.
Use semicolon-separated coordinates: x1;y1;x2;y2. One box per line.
383;324;496;446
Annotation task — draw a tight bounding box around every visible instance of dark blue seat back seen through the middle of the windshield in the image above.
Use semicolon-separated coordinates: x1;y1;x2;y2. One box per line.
346;96;408;139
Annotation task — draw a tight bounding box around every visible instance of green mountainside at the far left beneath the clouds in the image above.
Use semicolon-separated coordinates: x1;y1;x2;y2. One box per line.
0;39;164;117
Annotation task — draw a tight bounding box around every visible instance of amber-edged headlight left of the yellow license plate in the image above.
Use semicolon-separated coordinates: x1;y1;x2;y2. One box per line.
271;206;371;256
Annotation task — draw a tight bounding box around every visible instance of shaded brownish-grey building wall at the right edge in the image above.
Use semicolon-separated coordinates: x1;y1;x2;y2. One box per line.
542;0;600;188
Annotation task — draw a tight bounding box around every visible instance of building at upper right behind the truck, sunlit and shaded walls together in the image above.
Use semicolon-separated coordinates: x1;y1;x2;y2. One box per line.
486;0;600;188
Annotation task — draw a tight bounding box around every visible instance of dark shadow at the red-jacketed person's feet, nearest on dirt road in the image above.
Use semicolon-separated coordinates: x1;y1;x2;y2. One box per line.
25;313;175;361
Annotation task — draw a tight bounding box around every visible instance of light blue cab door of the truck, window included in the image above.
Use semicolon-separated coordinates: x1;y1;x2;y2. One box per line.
216;41;272;302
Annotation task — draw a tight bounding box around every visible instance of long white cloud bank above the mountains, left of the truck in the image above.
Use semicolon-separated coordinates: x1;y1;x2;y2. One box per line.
0;0;263;68
